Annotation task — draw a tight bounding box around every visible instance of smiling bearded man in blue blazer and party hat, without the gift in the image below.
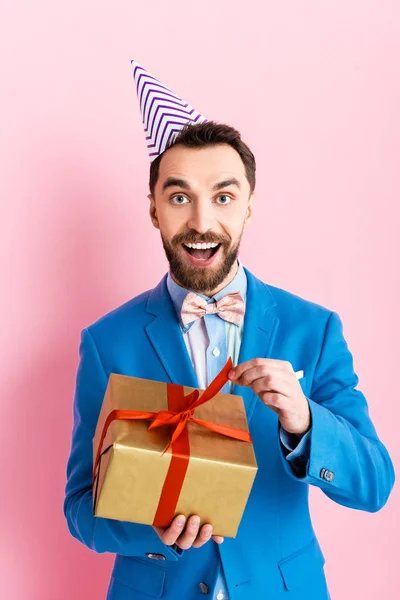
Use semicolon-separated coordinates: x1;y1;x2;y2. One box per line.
64;63;394;600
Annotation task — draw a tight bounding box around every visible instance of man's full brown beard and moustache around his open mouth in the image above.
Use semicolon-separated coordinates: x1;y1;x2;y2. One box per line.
161;228;243;293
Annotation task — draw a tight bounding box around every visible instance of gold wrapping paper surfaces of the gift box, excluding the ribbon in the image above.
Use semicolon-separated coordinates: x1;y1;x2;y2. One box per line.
93;373;257;537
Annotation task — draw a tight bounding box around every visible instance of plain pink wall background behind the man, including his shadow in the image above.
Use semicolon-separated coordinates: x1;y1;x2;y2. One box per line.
0;0;400;600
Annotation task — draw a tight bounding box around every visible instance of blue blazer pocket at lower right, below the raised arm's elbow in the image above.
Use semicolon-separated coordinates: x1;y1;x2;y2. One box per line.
278;537;325;590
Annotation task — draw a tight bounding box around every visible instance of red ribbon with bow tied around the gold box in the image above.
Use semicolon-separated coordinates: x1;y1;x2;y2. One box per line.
93;358;251;527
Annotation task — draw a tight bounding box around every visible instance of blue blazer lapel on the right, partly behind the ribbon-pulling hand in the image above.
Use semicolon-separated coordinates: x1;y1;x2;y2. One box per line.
233;269;279;421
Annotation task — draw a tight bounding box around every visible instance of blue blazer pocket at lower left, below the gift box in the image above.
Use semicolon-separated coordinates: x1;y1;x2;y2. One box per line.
112;556;166;598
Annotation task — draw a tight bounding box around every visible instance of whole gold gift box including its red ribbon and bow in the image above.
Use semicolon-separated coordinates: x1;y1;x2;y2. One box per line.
93;359;257;537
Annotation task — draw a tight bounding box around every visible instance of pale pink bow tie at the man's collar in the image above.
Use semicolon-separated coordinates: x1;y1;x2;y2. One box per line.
181;292;244;327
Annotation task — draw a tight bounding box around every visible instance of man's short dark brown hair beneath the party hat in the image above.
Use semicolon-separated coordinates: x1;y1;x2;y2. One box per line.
149;121;256;194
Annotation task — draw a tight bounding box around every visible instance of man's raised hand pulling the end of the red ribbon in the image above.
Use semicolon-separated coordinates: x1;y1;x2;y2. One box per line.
229;358;311;437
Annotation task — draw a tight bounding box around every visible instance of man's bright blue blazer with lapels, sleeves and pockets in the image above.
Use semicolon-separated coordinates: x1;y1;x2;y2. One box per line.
64;270;394;600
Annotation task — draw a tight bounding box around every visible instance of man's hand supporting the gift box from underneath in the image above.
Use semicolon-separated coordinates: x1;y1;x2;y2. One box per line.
154;515;224;550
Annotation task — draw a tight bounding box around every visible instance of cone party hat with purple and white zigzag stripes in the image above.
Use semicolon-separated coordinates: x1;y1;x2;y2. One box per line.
132;60;207;161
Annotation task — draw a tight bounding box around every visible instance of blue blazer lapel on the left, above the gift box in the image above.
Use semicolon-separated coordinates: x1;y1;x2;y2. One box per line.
146;275;198;388
